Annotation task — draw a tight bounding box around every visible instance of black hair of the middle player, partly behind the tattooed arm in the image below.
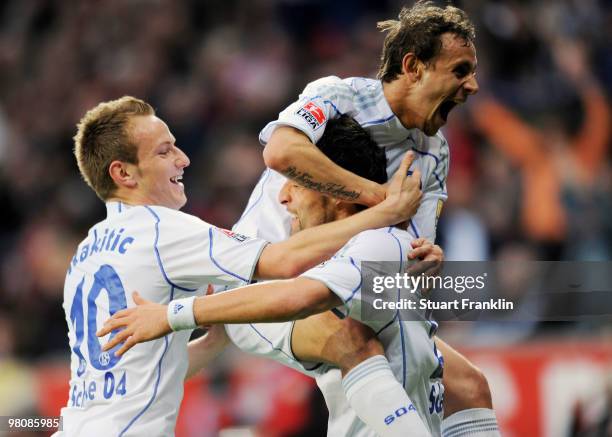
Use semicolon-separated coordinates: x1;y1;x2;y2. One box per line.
317;115;387;184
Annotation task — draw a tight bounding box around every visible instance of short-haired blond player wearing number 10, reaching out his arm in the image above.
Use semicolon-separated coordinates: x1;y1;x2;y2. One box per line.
57;97;420;436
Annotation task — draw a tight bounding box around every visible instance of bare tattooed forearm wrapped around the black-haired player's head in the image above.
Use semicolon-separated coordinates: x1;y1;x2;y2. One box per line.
263;126;385;206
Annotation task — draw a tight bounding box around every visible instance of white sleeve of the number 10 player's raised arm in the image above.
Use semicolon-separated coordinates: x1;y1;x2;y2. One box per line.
151;208;267;289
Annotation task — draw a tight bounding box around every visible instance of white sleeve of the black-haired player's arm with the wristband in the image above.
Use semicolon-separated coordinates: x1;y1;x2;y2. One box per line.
301;230;406;320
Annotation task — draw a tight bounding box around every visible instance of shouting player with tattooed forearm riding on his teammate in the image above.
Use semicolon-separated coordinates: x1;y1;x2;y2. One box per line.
229;2;499;437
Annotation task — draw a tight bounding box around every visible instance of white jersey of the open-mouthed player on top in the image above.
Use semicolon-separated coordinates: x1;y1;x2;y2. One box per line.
233;76;449;242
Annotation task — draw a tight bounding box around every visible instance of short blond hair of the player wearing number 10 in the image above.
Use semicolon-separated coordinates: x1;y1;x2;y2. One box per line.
74;96;155;200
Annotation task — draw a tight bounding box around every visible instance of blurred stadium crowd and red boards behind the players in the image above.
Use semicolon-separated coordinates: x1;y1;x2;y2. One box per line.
0;0;612;437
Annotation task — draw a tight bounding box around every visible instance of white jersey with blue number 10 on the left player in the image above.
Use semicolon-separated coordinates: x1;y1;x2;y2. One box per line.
56;202;266;437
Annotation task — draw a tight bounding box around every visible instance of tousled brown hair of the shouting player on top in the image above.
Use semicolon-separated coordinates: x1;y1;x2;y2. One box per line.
377;1;476;82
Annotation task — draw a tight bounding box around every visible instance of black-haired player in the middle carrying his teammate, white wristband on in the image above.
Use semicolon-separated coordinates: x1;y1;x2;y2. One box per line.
102;116;443;437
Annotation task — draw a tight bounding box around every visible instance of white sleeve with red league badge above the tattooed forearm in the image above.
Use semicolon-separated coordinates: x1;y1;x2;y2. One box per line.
259;76;352;145
